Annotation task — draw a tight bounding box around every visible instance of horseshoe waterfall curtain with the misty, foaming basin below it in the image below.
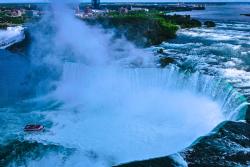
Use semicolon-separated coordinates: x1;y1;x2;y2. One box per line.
1;51;248;167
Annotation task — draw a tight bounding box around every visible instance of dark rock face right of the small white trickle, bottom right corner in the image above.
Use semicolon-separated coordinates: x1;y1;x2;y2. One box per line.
181;122;250;167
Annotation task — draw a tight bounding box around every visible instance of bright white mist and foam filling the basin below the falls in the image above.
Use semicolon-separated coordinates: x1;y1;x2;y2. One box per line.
22;63;225;167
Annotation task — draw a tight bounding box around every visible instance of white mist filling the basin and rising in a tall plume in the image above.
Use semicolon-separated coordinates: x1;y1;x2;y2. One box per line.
23;1;223;167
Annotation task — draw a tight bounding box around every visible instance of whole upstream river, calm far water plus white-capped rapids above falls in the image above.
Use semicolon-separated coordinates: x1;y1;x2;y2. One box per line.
161;4;250;102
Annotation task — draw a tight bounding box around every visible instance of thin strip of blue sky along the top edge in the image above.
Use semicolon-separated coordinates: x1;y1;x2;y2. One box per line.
0;0;250;3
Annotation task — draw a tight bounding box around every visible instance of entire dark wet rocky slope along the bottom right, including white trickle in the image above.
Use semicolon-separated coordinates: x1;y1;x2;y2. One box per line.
114;121;250;167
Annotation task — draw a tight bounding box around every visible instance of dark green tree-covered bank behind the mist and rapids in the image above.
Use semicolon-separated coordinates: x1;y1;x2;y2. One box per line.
84;11;201;47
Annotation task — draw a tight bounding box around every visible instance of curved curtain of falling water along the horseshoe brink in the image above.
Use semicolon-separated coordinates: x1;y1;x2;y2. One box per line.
62;63;248;120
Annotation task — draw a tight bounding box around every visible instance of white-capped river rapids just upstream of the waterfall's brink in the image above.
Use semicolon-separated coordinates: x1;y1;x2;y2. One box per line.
157;22;250;96
